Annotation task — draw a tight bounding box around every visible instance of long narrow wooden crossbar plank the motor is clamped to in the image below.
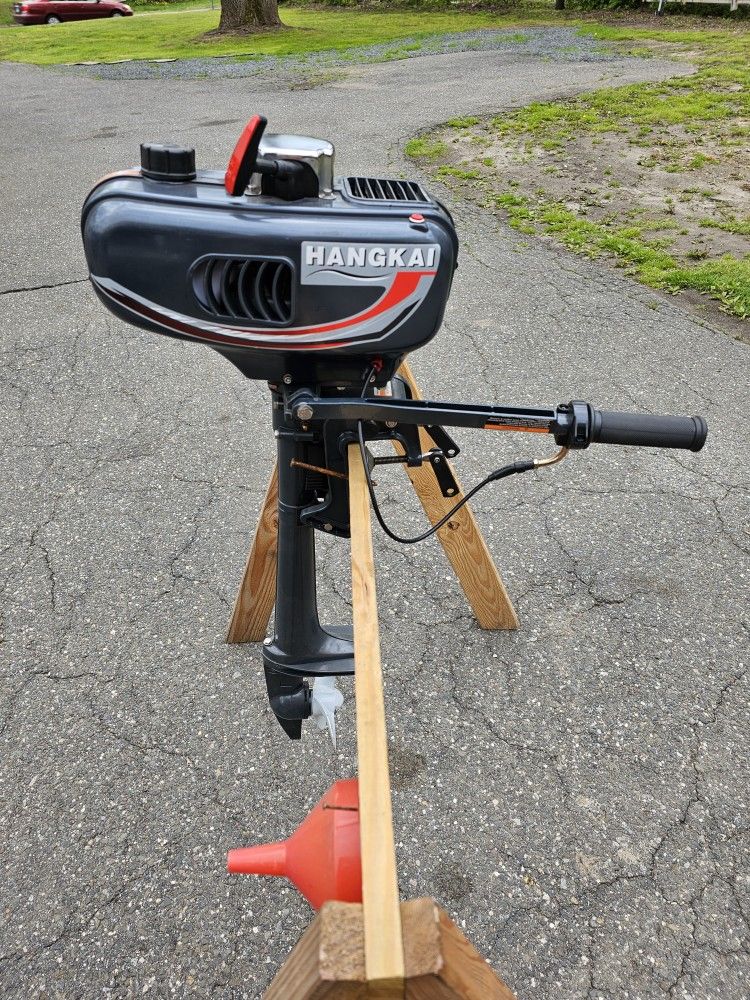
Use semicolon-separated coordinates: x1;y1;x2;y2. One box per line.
349;444;404;998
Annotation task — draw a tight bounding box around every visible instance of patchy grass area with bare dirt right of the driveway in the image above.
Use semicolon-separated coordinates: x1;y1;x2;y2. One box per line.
407;22;750;319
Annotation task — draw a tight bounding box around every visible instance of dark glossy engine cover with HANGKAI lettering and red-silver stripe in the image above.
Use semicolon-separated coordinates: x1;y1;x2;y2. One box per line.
82;170;458;385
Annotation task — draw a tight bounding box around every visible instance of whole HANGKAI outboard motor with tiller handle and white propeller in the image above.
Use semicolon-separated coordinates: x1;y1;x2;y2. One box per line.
82;115;707;739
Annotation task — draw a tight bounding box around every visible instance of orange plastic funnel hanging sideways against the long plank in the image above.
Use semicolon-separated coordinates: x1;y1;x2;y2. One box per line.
227;778;362;910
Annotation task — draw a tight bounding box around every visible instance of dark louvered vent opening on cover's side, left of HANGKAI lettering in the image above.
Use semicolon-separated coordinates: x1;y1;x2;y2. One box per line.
192;257;294;325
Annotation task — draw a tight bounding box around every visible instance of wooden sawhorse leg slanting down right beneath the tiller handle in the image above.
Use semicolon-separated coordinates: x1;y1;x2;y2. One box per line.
396;361;519;629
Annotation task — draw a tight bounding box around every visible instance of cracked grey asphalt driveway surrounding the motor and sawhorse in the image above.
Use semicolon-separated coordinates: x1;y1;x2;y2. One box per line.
0;43;750;1000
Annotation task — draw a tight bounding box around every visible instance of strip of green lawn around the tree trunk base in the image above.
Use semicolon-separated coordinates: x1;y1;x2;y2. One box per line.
0;7;540;65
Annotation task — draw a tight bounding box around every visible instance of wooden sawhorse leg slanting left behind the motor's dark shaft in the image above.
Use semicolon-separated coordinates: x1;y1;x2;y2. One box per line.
227;465;279;642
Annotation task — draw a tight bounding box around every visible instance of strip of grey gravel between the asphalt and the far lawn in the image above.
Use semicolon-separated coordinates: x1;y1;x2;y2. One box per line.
65;28;616;85
